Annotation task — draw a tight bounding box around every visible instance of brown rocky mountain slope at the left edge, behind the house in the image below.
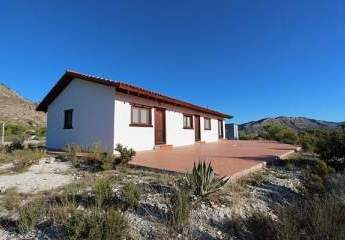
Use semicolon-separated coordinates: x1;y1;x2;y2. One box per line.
0;83;46;126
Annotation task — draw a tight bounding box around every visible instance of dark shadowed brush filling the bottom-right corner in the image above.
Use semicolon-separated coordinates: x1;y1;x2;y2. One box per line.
225;196;345;240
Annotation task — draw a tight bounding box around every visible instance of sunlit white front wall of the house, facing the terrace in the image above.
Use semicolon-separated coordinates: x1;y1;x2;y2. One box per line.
114;93;225;151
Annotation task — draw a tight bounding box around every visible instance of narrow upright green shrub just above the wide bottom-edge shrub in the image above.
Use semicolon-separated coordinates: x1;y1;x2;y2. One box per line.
94;178;113;207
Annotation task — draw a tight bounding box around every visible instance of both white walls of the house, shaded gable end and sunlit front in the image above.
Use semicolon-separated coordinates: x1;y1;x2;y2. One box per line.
47;79;225;152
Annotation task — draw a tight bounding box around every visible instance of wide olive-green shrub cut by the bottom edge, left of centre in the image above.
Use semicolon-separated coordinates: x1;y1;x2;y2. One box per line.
66;209;129;240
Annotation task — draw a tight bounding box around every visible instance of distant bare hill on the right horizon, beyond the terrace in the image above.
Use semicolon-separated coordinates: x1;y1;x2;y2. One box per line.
234;117;341;135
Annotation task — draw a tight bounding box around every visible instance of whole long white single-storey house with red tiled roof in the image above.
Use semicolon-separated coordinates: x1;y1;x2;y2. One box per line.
37;71;231;152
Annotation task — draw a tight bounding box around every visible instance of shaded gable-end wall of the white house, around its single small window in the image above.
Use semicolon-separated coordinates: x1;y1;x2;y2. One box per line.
47;79;115;152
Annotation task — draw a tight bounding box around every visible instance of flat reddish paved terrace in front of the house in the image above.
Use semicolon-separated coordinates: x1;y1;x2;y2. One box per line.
130;141;298;177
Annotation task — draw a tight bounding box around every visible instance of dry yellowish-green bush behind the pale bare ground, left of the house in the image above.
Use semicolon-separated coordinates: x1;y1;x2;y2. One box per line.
13;150;45;172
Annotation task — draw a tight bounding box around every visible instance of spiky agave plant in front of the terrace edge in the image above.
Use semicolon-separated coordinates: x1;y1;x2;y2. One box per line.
187;161;229;196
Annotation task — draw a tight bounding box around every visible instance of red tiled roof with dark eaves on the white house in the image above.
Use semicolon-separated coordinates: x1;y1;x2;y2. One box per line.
36;71;232;118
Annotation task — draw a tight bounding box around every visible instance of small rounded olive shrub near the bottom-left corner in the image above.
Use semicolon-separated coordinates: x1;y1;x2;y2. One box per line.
18;200;46;233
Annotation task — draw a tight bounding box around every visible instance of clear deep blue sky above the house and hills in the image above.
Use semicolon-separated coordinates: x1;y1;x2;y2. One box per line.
0;0;345;123
